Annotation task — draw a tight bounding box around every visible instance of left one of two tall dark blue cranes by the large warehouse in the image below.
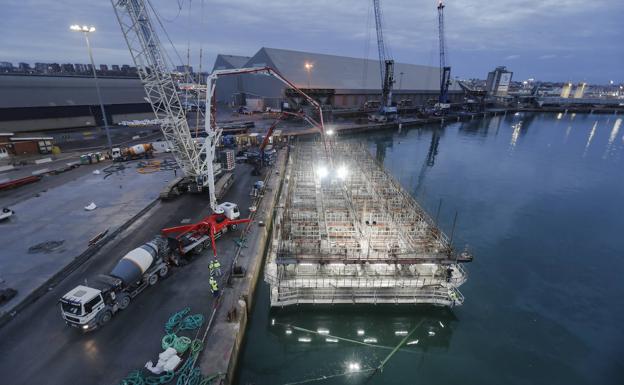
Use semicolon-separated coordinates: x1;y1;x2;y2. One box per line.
369;0;397;122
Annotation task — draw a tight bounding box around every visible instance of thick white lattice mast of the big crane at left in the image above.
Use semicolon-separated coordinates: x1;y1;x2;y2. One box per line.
111;0;219;210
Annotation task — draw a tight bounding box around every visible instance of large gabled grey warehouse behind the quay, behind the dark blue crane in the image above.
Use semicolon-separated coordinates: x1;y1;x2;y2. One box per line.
213;47;463;109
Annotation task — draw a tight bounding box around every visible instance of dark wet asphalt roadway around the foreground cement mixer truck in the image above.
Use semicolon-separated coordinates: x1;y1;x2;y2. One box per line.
0;160;257;385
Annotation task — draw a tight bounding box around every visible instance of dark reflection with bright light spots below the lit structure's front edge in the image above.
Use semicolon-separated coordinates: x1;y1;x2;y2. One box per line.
266;305;457;354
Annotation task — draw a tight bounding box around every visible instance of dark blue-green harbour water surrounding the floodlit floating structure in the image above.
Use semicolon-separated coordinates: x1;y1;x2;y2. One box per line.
237;113;624;385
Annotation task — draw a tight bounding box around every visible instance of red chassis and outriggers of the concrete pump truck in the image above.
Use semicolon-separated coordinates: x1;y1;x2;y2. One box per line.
161;206;251;257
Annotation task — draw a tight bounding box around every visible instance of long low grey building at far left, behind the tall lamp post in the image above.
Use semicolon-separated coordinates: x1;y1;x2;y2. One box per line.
0;74;154;132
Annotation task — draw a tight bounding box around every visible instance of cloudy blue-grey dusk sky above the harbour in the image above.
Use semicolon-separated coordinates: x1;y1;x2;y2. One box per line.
0;0;624;84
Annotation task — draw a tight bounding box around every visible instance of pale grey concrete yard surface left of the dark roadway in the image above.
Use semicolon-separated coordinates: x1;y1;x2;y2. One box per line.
0;154;174;314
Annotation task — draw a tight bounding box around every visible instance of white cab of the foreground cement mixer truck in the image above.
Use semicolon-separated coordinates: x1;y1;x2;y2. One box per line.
59;285;106;331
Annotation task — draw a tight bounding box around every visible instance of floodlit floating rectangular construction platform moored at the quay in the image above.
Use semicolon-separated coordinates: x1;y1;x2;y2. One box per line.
265;141;472;306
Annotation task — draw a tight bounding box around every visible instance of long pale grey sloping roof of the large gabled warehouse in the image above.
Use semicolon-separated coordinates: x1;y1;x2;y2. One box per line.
239;47;459;91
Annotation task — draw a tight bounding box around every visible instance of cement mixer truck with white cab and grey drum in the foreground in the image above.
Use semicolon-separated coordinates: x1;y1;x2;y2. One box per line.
59;237;171;331
